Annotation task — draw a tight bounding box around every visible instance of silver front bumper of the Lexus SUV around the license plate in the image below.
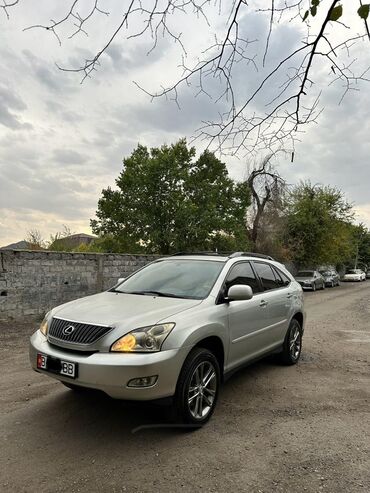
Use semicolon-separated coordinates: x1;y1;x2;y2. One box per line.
29;331;190;400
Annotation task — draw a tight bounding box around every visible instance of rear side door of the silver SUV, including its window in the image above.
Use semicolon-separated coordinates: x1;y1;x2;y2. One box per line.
252;261;292;351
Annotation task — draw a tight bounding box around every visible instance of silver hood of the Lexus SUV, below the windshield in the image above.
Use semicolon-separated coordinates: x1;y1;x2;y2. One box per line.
51;292;202;330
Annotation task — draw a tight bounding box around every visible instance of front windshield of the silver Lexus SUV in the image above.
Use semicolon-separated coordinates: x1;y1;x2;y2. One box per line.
111;259;224;299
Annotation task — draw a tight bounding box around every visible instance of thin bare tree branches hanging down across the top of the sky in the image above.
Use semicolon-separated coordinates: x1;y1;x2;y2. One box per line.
0;0;370;154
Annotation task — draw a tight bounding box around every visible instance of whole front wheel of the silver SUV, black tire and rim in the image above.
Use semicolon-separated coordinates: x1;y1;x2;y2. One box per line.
174;347;221;427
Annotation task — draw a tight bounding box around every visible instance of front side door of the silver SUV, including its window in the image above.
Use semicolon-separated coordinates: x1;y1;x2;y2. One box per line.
224;261;266;369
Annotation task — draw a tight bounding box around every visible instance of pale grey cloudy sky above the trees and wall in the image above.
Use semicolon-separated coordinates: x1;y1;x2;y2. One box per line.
0;0;370;246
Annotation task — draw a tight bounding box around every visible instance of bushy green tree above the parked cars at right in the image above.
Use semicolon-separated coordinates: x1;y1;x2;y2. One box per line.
286;182;354;267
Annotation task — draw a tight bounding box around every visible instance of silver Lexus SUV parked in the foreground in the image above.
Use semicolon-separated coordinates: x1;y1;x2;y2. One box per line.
30;253;304;425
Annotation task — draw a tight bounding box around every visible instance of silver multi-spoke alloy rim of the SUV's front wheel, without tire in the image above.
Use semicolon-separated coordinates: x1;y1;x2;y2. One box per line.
188;361;217;420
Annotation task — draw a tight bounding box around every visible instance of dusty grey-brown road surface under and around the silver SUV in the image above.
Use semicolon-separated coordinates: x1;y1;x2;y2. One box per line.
0;282;370;493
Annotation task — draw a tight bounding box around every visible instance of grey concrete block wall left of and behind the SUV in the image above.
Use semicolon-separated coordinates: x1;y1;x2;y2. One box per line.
0;250;158;321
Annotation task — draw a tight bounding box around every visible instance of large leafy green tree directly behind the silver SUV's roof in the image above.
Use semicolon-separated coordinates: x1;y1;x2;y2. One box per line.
91;139;250;254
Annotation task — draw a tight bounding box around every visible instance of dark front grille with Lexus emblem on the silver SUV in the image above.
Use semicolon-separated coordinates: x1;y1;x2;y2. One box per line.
48;318;112;344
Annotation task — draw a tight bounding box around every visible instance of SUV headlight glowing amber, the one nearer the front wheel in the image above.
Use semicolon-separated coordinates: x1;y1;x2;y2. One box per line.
110;323;176;353
